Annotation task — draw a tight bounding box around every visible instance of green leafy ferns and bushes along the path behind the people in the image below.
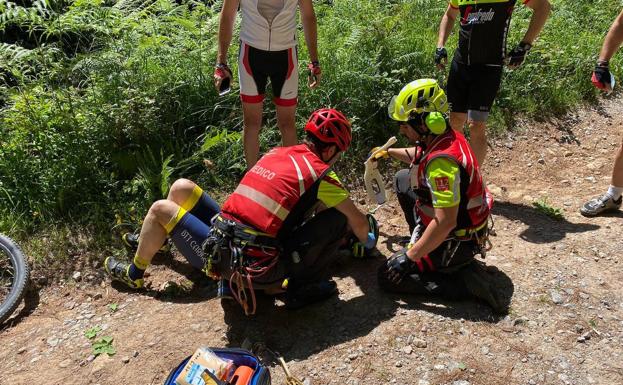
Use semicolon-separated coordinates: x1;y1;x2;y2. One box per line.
0;0;619;264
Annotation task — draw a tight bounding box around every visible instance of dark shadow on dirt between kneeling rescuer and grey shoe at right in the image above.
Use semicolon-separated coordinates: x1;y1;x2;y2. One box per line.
493;202;600;244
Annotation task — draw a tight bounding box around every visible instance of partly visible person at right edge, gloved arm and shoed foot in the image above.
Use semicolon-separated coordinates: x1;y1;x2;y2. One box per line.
580;11;623;217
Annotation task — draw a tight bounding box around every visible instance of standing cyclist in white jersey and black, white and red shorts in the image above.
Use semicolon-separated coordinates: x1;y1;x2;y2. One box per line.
214;0;321;169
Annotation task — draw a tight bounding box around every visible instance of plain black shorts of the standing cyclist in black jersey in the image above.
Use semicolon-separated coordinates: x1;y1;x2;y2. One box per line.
447;60;502;122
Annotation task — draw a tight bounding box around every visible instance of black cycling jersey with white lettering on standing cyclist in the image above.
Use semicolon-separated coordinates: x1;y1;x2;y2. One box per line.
450;0;529;65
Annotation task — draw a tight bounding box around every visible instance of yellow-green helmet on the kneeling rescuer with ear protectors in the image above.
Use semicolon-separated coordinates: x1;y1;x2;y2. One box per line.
387;79;448;122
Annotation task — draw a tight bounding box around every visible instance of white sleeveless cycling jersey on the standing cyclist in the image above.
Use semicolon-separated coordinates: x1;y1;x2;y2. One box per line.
240;0;298;51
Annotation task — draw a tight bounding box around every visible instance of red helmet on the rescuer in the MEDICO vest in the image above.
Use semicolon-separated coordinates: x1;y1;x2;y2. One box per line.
305;108;351;151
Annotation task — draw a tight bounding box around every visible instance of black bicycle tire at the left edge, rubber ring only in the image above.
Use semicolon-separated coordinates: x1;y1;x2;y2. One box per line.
0;234;30;324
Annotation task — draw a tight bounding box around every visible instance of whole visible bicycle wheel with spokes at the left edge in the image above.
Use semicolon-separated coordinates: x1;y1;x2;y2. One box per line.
0;234;30;324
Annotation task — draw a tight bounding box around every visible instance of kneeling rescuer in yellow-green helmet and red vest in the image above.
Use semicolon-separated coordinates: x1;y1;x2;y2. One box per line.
378;79;503;311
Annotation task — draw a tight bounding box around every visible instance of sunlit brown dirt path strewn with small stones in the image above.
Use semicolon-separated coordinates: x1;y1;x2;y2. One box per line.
0;100;623;385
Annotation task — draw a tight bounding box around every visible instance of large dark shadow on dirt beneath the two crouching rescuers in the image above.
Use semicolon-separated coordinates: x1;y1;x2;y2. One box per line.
221;257;513;360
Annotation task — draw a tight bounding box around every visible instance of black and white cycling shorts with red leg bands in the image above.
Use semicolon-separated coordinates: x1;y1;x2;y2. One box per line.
238;42;299;106
